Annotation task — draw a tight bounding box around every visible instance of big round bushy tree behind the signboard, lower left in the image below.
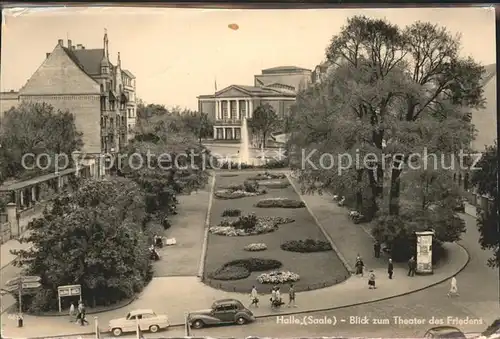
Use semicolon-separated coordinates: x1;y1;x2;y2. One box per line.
15;178;152;311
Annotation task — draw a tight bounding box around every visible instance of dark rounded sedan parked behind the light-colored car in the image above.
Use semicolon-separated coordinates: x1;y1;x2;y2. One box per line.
188;299;255;328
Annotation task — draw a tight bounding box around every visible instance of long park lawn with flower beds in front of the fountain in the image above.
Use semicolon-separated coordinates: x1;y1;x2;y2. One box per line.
204;173;348;293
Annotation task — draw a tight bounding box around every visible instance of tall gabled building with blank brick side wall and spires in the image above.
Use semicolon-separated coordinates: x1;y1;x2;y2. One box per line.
2;33;136;158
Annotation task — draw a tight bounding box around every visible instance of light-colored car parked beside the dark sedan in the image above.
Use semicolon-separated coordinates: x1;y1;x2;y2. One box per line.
109;309;170;337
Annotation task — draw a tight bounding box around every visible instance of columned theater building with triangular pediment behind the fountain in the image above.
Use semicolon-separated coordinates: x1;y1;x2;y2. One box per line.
198;66;311;140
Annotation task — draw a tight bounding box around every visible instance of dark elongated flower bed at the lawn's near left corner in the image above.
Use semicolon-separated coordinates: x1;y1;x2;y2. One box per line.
209;258;283;280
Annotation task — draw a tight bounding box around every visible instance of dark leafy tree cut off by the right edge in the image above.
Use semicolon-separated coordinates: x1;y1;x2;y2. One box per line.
471;142;500;268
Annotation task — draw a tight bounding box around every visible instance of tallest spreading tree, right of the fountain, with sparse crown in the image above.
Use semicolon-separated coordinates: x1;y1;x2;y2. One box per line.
288;16;484;260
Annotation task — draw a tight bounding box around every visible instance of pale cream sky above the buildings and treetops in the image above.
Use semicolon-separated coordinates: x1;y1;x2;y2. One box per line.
0;7;496;109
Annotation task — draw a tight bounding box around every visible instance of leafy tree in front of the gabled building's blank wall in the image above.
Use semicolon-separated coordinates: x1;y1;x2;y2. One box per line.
0;103;83;185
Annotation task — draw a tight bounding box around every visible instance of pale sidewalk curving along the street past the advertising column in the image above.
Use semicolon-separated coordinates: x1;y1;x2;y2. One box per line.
2;244;468;338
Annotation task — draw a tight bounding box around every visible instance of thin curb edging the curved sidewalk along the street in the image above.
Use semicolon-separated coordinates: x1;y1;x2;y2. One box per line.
8;243;470;339
